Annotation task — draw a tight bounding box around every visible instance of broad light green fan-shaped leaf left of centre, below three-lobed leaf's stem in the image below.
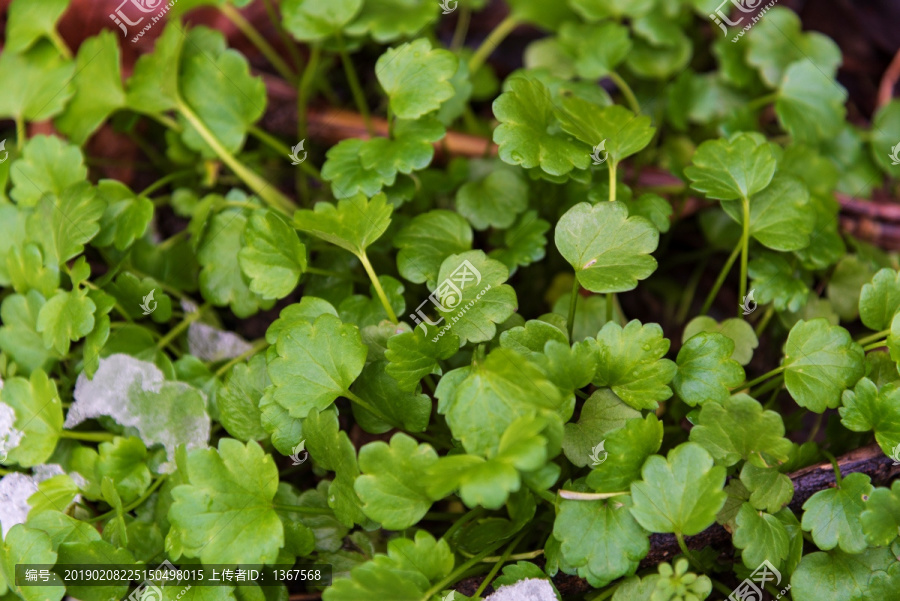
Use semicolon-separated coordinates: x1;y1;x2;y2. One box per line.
266;314;367;418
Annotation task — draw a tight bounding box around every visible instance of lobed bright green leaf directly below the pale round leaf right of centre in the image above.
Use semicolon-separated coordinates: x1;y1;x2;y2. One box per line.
593;319;677;409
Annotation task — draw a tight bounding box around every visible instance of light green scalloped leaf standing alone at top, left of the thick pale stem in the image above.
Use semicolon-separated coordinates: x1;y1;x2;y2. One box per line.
375;38;458;119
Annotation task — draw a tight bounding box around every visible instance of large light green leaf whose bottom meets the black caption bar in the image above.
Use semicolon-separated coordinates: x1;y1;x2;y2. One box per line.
168;438;284;563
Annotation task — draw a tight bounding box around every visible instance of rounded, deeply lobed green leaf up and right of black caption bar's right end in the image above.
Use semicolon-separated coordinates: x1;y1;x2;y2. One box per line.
353;433;437;530
